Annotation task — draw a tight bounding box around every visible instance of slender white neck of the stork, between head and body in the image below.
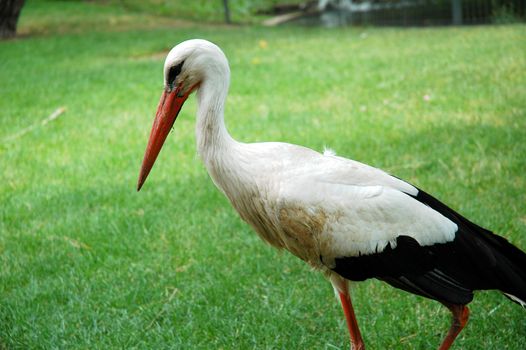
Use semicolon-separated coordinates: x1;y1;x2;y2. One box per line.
196;72;236;167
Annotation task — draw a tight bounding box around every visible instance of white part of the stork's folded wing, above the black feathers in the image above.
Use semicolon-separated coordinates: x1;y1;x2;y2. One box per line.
278;149;457;259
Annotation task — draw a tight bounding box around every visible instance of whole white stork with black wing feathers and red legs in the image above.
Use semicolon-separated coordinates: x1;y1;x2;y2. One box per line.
137;40;526;349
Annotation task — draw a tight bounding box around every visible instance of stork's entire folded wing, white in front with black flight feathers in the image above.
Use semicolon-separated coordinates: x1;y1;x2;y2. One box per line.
276;146;524;304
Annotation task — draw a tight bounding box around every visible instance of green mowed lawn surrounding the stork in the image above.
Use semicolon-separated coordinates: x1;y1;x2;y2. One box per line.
0;1;526;349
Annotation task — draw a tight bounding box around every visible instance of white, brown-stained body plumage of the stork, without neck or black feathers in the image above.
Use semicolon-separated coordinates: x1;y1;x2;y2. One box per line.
205;138;457;267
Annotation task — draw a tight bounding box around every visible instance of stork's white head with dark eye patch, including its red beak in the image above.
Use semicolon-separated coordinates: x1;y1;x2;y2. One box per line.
137;39;228;191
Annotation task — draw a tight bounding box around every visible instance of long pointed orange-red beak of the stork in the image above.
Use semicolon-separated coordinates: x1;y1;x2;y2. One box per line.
137;88;192;191
